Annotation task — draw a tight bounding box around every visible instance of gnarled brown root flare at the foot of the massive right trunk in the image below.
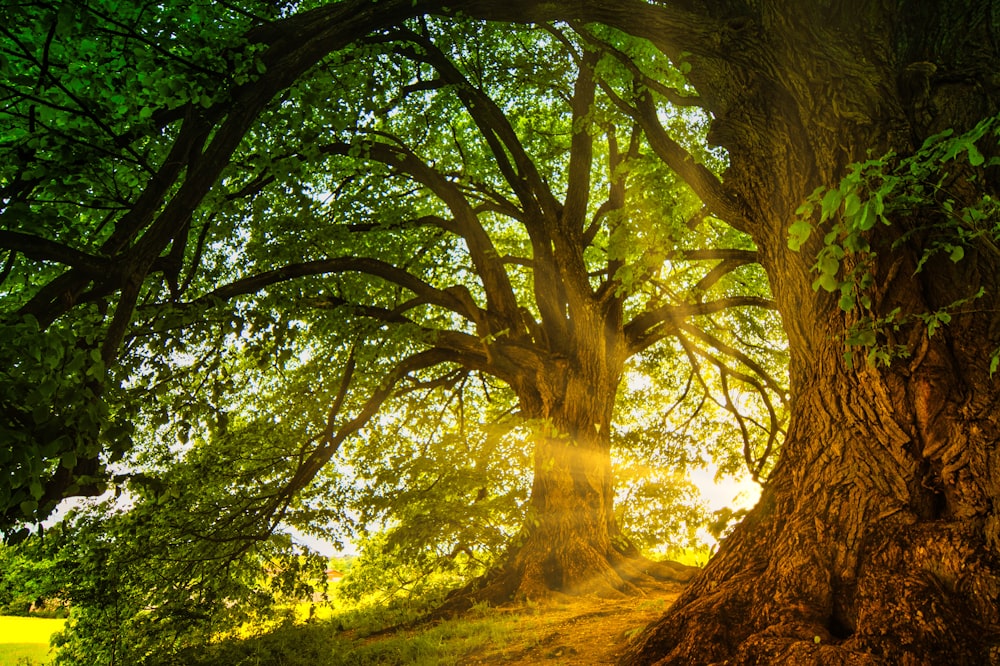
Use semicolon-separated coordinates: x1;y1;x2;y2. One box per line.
624;522;1000;666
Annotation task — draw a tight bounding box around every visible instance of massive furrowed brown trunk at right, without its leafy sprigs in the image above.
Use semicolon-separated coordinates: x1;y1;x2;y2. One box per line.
627;2;1000;666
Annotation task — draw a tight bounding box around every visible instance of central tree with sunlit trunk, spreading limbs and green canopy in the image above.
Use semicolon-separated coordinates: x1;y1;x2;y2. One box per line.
0;0;784;616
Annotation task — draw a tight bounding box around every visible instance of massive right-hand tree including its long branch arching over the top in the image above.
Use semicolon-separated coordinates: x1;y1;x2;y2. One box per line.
7;0;1000;664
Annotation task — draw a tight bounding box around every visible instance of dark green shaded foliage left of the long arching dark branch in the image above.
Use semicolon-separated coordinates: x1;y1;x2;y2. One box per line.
0;0;290;530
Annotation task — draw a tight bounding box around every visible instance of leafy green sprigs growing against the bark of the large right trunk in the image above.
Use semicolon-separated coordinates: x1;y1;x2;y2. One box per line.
788;112;1000;363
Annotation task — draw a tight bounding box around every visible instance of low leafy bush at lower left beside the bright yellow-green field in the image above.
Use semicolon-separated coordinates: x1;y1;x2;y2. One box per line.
41;496;325;664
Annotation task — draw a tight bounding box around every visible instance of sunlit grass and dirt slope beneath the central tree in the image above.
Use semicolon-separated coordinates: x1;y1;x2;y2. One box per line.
174;584;683;666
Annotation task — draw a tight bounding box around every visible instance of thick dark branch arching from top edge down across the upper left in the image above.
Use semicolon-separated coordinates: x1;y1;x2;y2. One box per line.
21;0;448;326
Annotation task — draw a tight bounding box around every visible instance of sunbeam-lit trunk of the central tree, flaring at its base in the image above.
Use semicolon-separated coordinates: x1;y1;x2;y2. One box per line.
445;360;699;611
